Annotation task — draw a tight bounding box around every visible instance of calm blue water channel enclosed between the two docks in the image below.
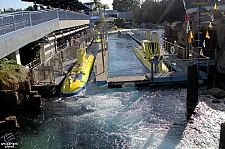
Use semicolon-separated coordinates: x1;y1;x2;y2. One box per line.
108;34;146;77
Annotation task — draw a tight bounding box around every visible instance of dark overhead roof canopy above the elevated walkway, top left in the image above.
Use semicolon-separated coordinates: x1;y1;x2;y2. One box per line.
21;0;91;10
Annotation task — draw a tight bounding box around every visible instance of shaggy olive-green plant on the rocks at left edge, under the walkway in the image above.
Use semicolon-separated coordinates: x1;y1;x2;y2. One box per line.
0;58;25;87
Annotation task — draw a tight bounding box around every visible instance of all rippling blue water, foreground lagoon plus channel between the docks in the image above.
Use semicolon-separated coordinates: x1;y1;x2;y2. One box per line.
16;30;225;149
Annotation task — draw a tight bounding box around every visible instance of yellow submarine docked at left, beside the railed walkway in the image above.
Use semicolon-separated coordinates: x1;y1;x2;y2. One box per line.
61;48;95;96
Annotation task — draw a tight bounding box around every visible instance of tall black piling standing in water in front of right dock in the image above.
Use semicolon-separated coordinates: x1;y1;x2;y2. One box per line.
186;64;198;119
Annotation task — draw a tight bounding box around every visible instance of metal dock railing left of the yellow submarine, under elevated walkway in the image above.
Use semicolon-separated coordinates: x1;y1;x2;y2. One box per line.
25;36;88;84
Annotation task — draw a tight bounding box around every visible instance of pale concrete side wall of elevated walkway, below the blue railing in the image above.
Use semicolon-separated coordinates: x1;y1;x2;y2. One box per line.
0;19;89;59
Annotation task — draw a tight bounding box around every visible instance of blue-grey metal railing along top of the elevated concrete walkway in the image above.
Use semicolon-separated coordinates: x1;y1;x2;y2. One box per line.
0;9;89;36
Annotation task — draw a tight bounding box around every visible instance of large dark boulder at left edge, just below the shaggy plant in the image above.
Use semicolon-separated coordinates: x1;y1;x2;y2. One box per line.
0;90;24;108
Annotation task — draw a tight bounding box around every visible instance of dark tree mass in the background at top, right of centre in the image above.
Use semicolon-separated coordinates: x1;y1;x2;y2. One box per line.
113;0;185;23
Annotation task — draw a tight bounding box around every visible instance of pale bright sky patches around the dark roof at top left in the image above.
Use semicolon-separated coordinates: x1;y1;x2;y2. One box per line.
0;0;113;11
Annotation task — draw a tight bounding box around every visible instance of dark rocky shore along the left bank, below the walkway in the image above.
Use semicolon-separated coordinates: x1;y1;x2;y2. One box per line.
0;67;42;134
